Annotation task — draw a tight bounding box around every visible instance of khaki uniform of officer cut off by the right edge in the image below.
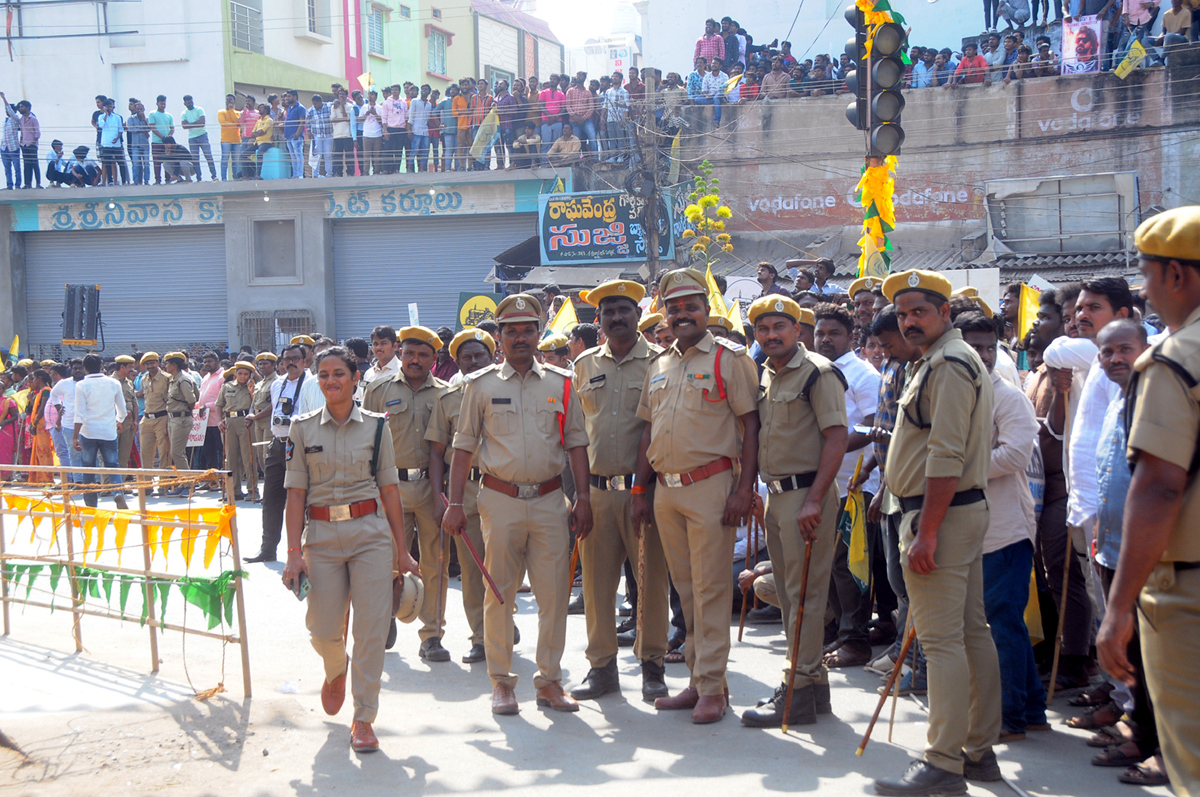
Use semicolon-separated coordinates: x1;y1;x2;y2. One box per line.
1129;308;1200;795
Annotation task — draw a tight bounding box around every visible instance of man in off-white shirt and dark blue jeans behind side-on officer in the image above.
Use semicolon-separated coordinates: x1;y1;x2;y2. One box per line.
954;312;1050;744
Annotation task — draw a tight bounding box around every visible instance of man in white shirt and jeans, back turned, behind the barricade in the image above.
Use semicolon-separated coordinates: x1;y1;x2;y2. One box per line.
71;354;128;509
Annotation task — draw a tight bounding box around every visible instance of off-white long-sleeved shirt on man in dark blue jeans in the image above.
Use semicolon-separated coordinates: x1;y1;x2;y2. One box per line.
983;368;1038;553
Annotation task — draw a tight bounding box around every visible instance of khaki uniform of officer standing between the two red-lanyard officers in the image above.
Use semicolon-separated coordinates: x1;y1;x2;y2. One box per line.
575;336;671;669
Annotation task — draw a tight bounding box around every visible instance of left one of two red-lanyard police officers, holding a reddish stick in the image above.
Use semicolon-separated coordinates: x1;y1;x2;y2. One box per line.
442;294;590;714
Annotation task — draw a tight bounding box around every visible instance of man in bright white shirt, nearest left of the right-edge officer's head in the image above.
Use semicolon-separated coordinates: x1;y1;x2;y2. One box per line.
1043;277;1133;689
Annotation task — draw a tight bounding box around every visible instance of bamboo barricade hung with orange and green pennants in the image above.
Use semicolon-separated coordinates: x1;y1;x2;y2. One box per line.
0;465;251;697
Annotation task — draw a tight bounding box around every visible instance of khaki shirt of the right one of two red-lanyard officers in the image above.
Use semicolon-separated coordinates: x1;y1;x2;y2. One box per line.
637;332;758;473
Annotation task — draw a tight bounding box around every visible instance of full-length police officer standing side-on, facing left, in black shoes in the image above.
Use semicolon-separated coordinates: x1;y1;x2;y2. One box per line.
875;270;1001;795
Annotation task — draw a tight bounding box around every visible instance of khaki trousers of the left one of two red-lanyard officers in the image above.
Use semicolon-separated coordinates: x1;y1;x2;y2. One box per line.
479;487;571;689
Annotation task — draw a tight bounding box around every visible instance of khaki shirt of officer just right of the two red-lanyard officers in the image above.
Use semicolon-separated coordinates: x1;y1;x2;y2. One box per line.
758;343;846;481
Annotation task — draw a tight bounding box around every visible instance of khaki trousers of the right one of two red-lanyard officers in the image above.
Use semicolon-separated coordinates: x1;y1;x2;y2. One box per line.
654;471;737;696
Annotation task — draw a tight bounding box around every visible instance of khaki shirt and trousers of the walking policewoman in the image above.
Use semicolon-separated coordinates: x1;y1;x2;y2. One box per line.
283;407;398;723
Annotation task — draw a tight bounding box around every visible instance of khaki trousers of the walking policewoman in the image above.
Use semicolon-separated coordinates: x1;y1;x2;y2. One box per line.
304;507;396;723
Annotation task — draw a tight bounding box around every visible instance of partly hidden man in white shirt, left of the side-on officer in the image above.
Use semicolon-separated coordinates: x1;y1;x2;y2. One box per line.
814;304;890;667
